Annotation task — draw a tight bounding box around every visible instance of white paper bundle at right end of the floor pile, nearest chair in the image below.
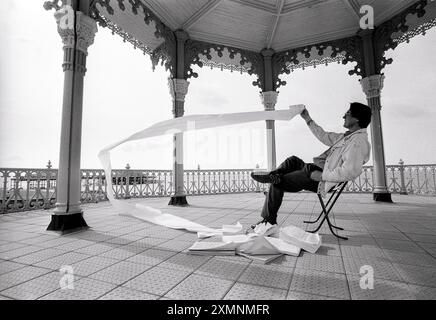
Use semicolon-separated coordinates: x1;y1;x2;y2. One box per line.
279;226;321;253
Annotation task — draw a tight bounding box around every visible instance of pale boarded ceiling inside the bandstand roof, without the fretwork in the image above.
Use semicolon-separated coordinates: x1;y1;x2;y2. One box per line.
91;0;432;51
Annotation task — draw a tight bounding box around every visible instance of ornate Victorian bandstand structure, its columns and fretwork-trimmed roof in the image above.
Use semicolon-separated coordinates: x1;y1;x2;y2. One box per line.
44;0;436;231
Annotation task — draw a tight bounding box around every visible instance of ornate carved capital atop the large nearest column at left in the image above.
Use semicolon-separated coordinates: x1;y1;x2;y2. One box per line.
54;5;98;55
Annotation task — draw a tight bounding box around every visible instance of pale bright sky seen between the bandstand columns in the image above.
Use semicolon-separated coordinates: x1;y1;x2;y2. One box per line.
0;0;436;169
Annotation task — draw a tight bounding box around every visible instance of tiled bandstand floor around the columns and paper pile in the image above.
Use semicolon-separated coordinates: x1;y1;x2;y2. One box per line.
0;193;436;300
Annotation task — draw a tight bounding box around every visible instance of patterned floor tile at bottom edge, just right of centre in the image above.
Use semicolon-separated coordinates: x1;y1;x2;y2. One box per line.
224;282;286;300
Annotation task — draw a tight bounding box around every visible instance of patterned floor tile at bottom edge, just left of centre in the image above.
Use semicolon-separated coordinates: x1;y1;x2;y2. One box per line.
165;274;233;300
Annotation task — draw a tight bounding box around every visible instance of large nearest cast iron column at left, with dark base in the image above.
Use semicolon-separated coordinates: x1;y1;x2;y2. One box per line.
45;1;97;231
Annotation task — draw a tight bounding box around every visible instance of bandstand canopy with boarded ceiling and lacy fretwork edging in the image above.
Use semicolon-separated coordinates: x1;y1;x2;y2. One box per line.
91;0;436;89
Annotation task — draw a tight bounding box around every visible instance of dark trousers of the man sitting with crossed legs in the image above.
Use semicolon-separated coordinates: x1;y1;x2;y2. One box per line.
262;156;322;224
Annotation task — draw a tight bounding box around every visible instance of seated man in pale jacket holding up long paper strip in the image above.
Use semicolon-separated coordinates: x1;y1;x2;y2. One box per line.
251;102;371;235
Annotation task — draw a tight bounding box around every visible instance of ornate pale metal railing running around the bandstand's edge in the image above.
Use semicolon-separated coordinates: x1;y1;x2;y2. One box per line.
0;161;436;213
